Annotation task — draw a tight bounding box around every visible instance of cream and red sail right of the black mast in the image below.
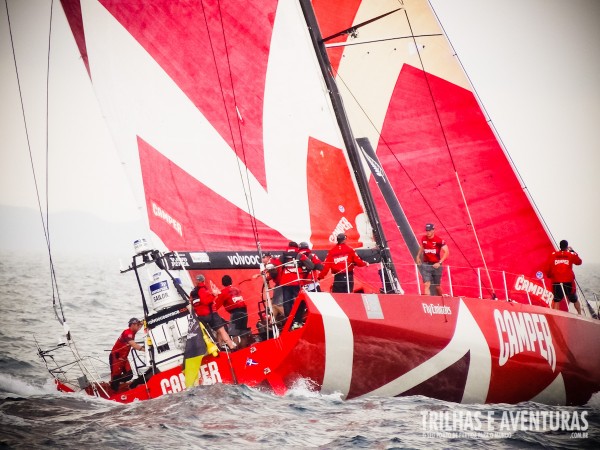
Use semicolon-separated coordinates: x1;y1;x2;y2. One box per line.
314;0;553;301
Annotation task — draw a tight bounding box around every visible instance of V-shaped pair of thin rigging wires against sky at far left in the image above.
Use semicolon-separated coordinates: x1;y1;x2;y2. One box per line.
4;0;66;325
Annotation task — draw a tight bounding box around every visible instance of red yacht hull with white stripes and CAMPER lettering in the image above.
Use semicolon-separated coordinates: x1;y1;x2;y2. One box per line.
59;293;600;405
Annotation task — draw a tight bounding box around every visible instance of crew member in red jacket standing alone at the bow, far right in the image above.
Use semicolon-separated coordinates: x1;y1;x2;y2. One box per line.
545;240;582;314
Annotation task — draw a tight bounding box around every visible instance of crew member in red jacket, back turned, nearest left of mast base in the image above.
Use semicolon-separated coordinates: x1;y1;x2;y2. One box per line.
319;233;369;293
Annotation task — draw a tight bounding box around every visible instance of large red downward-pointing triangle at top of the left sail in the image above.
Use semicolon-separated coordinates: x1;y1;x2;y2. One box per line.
102;0;277;186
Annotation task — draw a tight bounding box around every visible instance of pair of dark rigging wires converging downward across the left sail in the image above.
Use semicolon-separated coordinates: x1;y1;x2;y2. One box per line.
201;1;262;256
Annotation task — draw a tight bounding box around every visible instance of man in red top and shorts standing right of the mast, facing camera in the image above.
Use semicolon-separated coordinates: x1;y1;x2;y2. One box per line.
416;223;450;295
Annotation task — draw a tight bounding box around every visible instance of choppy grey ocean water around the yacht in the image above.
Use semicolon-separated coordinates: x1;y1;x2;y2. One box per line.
0;253;600;449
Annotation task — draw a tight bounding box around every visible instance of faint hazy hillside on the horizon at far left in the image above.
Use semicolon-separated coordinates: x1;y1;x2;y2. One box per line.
0;205;148;255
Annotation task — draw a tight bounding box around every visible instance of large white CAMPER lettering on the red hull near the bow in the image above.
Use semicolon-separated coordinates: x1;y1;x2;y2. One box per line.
494;309;556;372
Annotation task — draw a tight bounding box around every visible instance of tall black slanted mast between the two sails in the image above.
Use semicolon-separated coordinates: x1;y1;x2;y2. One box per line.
300;0;398;288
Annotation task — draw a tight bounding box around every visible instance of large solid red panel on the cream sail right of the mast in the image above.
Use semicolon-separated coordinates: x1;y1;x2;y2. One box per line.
378;65;552;298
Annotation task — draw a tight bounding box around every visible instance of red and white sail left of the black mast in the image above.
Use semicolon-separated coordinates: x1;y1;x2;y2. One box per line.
63;0;374;251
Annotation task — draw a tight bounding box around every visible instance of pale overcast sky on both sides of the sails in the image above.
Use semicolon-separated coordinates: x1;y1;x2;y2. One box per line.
0;0;600;263
